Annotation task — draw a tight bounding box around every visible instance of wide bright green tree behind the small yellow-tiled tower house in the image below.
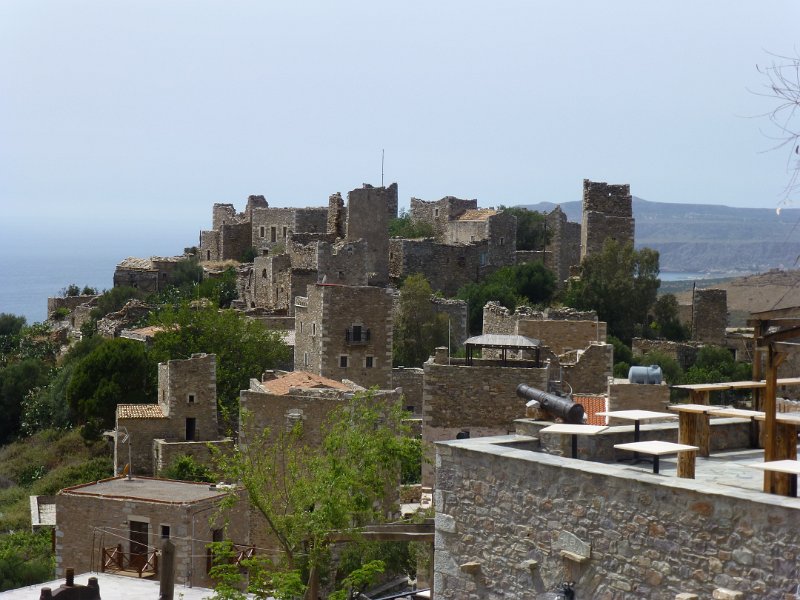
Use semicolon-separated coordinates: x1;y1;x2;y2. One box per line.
149;301;290;425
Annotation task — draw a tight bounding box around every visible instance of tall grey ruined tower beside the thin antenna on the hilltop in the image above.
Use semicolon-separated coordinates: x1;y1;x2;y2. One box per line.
345;183;397;286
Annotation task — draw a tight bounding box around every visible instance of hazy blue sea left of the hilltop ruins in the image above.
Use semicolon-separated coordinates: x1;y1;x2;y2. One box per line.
0;222;198;324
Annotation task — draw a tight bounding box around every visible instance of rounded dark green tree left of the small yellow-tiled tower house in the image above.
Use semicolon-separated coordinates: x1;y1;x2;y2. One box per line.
66;338;155;431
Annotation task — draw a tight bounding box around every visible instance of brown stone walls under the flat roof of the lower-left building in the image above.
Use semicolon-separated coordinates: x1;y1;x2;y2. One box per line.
55;479;248;587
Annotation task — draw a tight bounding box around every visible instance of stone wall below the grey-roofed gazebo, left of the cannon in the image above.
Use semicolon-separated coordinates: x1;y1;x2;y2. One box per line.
422;353;549;486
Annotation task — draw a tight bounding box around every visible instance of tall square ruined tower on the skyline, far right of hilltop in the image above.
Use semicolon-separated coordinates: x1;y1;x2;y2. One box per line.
581;179;634;259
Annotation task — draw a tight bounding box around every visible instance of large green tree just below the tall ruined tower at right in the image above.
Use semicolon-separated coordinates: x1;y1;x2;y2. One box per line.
564;238;661;344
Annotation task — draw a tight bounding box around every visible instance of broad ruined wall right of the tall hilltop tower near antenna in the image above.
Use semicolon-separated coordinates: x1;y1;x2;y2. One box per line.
389;239;491;296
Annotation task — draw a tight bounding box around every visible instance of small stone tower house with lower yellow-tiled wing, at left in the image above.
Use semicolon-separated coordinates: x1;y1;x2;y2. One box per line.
114;354;232;475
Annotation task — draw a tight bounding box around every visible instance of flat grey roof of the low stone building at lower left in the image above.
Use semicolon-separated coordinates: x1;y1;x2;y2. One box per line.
59;475;227;504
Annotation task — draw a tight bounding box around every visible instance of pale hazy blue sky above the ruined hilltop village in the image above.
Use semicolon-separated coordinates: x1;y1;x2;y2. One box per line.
0;0;800;254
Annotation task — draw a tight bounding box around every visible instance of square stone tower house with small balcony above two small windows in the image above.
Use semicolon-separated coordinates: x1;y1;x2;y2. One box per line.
294;284;392;389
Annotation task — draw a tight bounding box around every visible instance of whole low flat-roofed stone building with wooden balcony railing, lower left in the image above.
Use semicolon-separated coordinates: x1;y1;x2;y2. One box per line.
54;476;249;587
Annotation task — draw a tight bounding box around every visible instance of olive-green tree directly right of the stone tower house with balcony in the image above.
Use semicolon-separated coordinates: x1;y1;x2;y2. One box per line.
393;273;449;367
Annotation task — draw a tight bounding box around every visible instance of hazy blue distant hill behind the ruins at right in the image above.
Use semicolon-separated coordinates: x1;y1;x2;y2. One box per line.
523;197;800;274
